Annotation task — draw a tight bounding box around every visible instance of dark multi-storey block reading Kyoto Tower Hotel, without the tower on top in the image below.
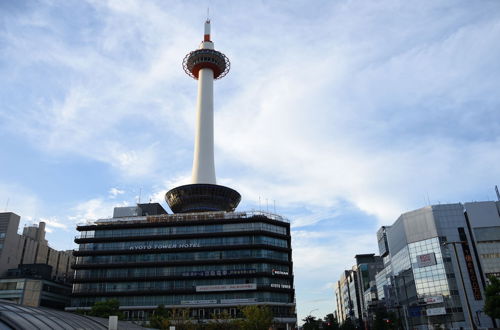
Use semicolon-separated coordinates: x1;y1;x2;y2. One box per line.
72;204;296;327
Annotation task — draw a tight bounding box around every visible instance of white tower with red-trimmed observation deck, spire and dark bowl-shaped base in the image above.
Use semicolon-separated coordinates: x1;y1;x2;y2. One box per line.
165;19;241;213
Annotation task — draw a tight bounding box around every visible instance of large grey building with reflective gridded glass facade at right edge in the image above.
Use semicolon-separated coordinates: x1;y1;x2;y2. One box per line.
376;202;500;329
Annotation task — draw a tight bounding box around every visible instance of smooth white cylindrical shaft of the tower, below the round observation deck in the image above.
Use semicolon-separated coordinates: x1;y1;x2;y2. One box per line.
192;68;216;184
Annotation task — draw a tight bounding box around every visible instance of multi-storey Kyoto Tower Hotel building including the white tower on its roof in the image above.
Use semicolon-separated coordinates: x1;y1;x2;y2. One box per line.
68;20;296;329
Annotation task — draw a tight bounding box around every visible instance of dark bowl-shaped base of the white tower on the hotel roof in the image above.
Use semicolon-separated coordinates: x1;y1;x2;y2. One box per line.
165;183;241;213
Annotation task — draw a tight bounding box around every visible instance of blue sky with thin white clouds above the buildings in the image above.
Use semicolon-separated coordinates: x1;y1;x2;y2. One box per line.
0;0;500;319
